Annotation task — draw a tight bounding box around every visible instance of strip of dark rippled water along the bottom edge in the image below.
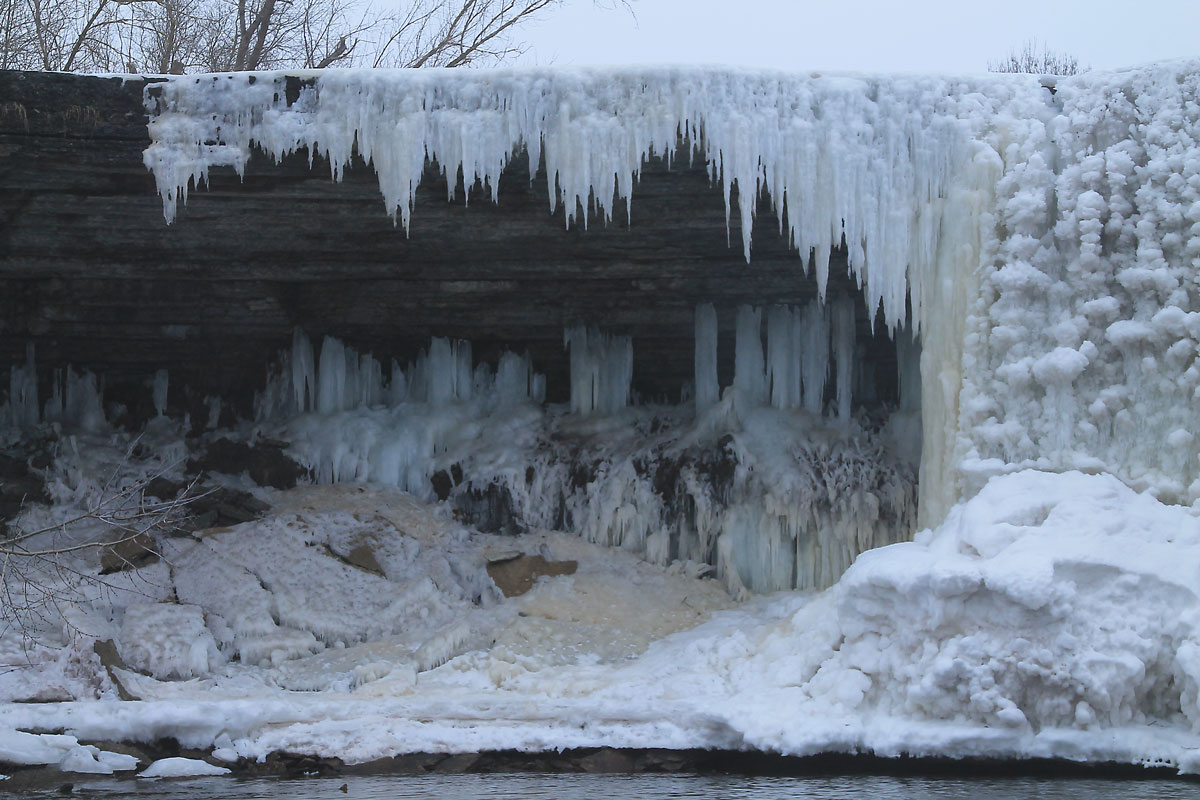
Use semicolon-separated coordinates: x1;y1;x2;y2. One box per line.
16;774;1200;800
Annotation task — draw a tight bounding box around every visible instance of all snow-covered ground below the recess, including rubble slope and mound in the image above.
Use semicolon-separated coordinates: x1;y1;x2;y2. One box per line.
0;450;1200;771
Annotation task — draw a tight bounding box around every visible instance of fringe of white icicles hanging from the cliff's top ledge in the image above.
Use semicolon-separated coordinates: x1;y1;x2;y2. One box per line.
145;67;1022;327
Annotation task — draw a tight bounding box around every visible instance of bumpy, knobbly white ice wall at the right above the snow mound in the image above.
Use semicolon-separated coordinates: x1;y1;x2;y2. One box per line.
959;62;1200;503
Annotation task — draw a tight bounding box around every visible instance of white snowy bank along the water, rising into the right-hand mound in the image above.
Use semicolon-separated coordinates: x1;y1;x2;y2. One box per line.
7;471;1200;772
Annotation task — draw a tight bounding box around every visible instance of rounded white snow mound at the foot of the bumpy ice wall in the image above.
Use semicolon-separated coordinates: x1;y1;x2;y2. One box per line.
812;471;1200;732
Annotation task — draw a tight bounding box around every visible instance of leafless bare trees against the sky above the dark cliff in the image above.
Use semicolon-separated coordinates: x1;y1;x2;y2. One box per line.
0;0;590;73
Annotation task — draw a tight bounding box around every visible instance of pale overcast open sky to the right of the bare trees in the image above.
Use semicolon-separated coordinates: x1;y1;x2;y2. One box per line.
520;0;1200;73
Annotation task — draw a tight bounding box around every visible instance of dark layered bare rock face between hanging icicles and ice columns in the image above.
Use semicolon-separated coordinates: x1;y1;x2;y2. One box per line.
0;72;895;415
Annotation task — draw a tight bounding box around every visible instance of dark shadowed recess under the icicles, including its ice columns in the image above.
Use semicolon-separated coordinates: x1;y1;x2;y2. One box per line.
0;73;922;595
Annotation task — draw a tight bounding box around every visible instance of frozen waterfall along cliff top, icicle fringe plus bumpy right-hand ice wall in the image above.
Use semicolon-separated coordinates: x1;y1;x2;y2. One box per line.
145;62;1200;524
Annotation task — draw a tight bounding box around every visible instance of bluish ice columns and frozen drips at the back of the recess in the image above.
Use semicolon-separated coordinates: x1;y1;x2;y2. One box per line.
243;319;916;593
